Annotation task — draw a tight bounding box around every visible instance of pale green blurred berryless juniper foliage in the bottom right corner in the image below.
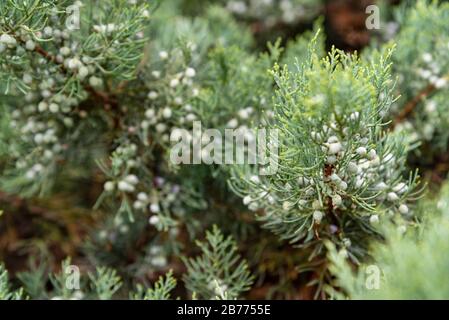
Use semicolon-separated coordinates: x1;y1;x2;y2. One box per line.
330;185;449;300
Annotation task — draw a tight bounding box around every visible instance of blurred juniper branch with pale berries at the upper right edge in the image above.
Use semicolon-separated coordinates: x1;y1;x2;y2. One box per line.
382;1;449;154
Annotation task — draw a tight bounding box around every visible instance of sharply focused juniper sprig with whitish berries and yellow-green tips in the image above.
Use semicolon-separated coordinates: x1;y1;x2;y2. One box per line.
231;40;418;290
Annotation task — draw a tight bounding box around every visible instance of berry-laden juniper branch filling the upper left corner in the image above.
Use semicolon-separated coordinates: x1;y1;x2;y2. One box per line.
0;0;150;196
